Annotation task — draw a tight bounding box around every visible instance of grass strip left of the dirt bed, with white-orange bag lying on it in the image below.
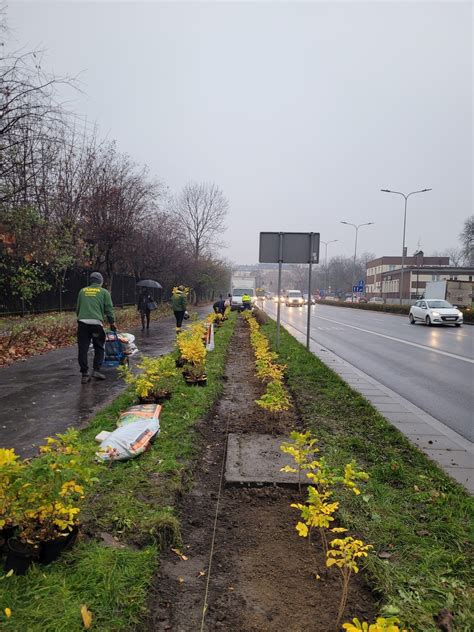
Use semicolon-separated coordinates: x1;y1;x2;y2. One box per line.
0;314;236;632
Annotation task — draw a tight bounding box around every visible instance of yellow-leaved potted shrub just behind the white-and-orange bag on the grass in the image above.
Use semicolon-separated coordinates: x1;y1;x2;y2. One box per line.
119;356;178;404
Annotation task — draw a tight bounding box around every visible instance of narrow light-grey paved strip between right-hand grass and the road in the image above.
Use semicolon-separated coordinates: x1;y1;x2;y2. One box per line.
282;324;474;494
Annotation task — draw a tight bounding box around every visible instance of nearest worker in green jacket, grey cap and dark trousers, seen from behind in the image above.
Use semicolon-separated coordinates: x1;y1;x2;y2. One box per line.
76;272;117;384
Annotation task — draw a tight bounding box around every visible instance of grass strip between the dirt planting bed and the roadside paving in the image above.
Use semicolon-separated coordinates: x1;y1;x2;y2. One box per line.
263;320;474;632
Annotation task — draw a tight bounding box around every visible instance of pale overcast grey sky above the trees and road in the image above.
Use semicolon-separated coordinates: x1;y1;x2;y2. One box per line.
8;0;473;263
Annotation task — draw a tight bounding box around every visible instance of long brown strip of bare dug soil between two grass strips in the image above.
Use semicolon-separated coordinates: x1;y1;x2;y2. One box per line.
147;321;376;632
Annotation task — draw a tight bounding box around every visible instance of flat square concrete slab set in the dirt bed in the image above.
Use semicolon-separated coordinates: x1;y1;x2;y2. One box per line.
225;433;298;485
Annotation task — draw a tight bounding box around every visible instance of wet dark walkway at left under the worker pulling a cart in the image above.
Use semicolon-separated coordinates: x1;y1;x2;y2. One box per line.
0;307;209;457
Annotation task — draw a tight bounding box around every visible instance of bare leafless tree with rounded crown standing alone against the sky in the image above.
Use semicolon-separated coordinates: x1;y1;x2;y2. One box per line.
173;183;229;261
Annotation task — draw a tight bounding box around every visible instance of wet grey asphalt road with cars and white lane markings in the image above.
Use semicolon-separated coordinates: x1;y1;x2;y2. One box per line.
265;301;474;441
